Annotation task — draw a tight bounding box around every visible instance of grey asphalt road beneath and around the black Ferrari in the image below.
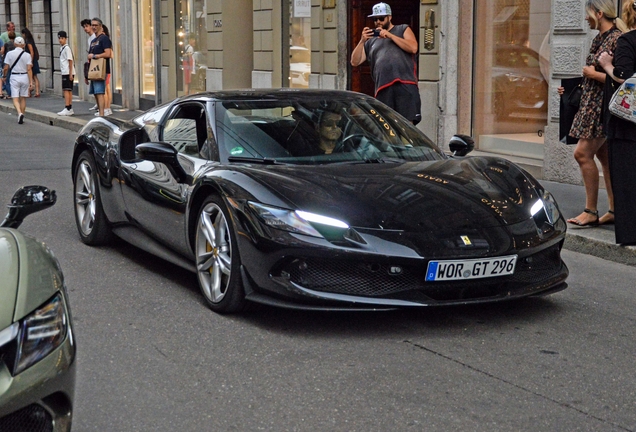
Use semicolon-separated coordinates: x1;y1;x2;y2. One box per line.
0;113;636;431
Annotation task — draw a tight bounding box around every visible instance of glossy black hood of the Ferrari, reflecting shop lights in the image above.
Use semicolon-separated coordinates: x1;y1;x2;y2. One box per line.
234;157;539;232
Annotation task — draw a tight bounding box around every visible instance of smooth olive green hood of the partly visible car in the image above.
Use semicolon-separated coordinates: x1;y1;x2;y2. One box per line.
0;228;63;329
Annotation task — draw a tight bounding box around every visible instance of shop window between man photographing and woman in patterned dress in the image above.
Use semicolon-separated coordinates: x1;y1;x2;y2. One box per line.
472;0;552;159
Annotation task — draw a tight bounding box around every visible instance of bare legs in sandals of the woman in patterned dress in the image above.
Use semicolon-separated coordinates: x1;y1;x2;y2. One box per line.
568;138;614;225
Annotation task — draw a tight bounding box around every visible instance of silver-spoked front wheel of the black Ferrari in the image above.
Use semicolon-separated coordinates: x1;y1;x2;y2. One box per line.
194;196;247;313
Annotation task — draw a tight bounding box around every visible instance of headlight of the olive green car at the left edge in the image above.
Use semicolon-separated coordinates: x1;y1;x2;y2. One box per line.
13;293;68;375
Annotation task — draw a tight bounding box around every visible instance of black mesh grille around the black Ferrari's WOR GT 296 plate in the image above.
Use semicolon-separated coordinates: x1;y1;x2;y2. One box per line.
277;245;563;301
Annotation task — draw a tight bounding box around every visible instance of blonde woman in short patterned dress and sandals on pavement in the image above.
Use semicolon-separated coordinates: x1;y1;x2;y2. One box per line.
559;0;627;227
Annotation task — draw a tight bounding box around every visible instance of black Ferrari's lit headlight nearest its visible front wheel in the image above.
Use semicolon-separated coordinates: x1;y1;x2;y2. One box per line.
248;202;349;238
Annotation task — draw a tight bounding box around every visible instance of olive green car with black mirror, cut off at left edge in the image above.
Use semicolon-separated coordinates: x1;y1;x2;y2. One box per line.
0;186;76;432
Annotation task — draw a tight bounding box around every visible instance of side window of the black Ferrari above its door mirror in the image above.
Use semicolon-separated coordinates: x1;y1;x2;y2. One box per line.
162;104;208;156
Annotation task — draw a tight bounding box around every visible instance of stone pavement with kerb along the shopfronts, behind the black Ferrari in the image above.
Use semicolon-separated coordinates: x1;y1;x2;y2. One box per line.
0;92;636;266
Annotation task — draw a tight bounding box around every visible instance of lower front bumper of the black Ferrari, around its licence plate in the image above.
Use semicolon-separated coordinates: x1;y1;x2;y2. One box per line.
243;241;569;310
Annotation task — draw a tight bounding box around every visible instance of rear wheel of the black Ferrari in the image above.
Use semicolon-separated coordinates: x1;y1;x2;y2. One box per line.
73;150;113;246
